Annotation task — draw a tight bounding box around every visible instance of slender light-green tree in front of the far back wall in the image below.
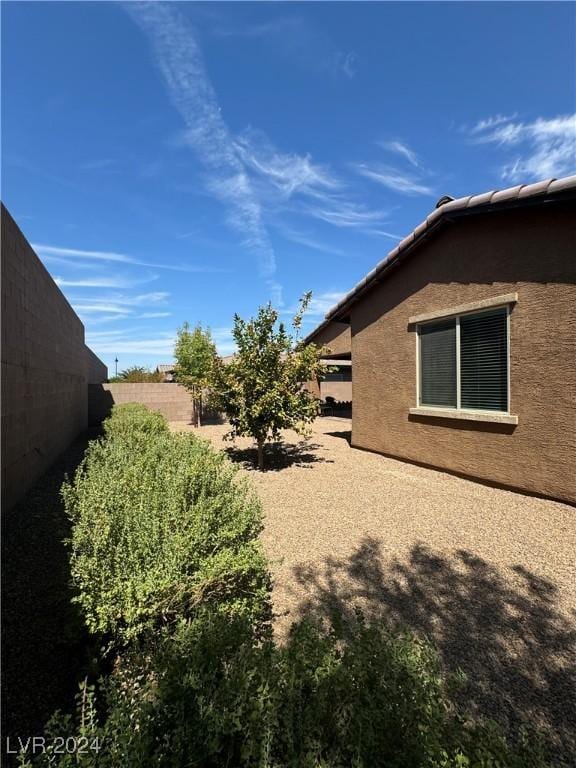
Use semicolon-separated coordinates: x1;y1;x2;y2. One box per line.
174;323;216;427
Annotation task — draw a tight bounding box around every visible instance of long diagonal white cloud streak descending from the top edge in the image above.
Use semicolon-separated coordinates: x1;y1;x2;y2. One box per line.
125;3;275;277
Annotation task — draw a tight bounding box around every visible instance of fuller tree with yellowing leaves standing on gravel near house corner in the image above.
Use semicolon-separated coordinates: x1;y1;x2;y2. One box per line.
212;292;326;469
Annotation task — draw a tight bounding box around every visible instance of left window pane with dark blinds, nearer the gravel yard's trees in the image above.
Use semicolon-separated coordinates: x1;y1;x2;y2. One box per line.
420;320;456;408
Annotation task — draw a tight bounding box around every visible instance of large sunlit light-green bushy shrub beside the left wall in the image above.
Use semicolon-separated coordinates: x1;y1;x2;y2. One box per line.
62;428;269;642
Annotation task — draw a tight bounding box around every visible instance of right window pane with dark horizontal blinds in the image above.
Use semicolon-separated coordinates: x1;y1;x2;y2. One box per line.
460;309;508;411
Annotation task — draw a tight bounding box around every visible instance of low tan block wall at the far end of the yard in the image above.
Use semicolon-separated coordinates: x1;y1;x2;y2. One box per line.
88;383;192;426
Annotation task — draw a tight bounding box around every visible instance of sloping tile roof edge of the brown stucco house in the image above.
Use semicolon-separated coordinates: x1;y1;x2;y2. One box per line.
324;175;576;324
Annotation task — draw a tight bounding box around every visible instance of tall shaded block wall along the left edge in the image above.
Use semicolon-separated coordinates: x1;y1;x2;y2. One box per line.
1;206;106;510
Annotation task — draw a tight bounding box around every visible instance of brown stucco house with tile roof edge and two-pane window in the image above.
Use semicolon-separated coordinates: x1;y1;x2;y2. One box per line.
311;176;576;512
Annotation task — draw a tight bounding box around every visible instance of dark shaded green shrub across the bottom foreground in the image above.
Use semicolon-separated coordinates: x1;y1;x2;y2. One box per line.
18;609;546;768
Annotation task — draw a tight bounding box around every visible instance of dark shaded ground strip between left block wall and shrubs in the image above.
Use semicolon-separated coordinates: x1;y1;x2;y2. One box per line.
2;431;98;764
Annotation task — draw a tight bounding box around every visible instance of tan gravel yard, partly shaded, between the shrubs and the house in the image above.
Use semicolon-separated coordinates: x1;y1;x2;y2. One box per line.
172;418;576;764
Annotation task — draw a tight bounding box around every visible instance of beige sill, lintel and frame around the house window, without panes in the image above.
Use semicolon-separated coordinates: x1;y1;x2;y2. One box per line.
408;293;518;424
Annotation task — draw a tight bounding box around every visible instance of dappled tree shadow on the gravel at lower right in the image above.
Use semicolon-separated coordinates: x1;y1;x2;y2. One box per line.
294;538;576;765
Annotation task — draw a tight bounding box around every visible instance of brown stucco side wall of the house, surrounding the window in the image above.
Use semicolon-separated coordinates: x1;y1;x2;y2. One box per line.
351;202;576;502
